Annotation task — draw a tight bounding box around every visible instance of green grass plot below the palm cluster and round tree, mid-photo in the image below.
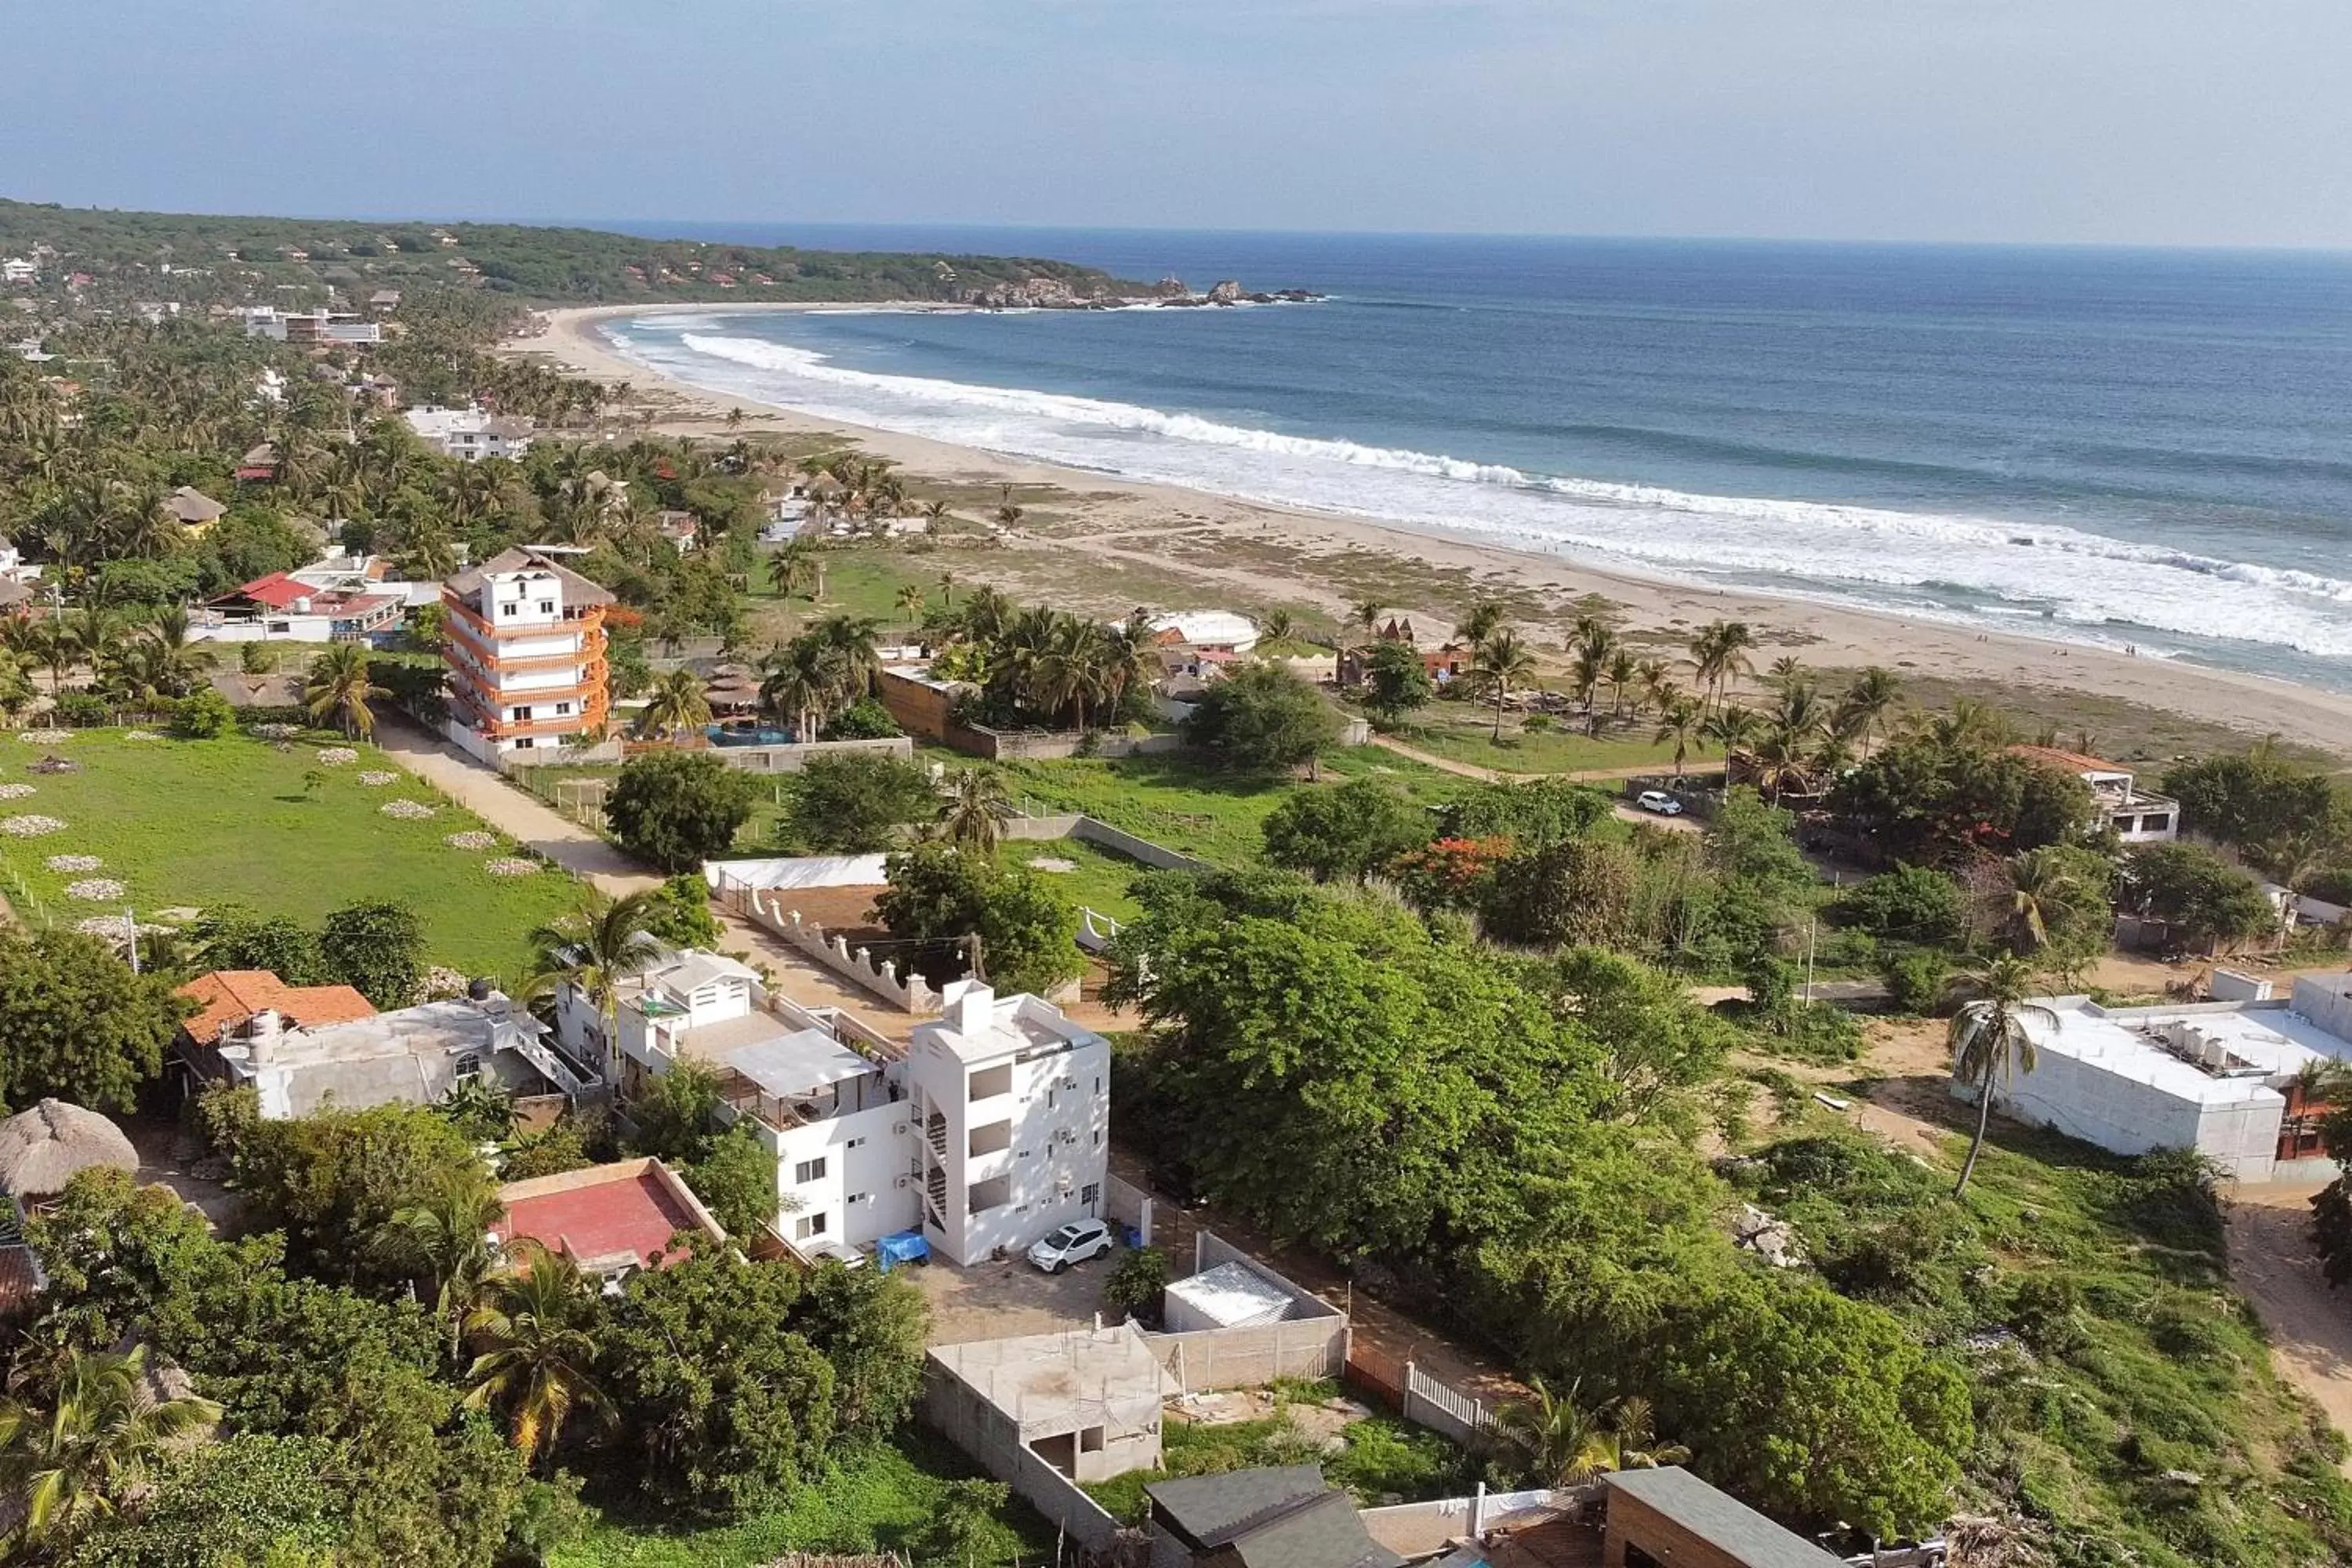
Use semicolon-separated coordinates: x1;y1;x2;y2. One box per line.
1004;746;1463;865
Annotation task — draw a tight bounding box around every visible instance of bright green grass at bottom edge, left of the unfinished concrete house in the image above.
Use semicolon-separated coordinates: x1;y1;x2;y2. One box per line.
548;1432;1054;1568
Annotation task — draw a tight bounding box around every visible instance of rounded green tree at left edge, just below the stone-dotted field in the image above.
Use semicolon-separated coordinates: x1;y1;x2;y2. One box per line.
0;926;191;1109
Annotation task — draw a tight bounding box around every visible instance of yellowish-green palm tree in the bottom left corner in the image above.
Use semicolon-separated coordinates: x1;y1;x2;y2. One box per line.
0;1345;221;1544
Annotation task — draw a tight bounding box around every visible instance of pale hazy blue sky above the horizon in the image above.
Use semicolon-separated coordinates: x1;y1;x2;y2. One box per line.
0;0;2352;247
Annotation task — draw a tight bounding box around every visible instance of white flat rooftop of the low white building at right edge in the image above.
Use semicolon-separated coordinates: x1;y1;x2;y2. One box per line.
2025;996;2352;1105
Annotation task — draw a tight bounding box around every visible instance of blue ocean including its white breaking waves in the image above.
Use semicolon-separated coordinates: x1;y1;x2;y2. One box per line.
583;226;2352;689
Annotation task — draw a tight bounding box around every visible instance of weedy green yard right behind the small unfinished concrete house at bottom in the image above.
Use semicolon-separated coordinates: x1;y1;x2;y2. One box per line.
1084;1382;1479;1521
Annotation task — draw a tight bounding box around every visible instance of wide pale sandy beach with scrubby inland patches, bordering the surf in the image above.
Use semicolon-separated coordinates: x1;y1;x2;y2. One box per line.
506;306;2352;757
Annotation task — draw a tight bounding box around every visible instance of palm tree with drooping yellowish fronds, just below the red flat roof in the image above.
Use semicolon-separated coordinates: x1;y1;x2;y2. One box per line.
466;1239;612;1467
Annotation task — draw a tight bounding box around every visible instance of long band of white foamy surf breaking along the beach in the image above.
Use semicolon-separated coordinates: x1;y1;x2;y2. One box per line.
614;318;2352;656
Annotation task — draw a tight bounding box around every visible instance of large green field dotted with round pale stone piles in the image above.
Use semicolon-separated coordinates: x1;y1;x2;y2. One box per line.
0;729;579;973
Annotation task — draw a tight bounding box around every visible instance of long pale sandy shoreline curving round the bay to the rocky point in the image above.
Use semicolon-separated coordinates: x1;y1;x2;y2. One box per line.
501;301;2352;760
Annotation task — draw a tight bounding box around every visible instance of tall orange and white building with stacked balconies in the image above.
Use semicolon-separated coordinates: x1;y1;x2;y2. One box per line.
442;548;614;767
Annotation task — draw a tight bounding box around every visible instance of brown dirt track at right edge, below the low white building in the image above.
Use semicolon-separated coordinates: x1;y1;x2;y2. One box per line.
2227;1182;2352;1474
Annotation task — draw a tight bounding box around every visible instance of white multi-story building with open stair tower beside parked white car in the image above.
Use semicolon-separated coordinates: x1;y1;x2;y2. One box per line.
557;952;1110;1265
